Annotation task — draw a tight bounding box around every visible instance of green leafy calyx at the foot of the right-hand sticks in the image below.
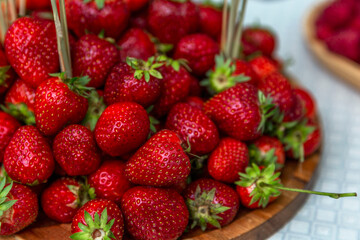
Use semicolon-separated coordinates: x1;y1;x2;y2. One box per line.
200;55;250;93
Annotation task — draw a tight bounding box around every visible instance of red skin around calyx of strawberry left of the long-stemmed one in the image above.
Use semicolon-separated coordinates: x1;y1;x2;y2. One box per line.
184;178;240;229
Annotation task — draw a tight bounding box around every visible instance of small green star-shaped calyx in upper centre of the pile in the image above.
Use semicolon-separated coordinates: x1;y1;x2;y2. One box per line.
126;56;164;82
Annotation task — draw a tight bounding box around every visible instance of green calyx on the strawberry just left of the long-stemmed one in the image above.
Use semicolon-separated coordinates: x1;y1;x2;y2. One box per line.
186;186;230;231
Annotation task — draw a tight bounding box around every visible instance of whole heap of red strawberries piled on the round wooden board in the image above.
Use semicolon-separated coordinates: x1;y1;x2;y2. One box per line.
0;0;321;240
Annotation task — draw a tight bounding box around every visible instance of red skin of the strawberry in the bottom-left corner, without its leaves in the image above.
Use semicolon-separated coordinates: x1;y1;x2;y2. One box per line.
0;182;39;236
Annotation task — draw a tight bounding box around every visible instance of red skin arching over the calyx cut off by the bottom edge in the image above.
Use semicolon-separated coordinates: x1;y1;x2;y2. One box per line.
71;199;124;240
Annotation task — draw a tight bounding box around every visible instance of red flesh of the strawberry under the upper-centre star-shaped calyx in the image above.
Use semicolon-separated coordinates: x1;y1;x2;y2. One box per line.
104;63;161;108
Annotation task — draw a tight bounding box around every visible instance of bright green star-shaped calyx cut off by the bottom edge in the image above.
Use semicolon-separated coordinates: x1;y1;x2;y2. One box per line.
70;208;116;240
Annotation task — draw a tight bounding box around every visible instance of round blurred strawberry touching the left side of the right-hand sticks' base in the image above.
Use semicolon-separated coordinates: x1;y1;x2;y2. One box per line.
174;33;219;76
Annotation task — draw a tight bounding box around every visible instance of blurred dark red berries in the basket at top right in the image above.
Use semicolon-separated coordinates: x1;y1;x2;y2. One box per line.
315;0;360;63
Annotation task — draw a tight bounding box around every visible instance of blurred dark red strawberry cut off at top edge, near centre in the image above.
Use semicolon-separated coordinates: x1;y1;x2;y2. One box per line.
147;0;199;44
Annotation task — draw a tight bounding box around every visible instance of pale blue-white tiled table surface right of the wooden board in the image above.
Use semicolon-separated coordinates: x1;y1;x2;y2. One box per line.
242;0;360;240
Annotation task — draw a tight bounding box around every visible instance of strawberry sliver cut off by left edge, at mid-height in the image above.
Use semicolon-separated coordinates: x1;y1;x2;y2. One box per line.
0;112;21;162
